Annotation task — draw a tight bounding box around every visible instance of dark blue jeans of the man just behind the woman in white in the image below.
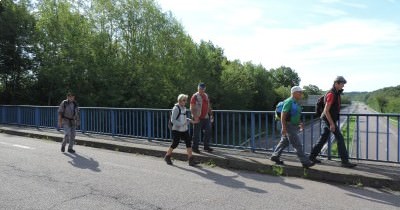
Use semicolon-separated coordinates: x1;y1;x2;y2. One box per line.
192;118;211;149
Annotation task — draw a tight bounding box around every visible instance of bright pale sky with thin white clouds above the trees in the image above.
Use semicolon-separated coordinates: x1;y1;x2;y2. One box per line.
156;0;400;92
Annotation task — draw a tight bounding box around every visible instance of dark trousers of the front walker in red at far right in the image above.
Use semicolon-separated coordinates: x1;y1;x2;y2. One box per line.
310;119;349;163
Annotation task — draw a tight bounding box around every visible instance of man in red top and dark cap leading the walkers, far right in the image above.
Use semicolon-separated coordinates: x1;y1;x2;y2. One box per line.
310;76;356;168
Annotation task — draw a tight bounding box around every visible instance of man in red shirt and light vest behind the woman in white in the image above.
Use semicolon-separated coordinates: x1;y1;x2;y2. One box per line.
190;82;213;153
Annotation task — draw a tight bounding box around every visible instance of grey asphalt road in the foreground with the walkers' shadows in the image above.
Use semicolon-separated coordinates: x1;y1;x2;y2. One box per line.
0;134;400;210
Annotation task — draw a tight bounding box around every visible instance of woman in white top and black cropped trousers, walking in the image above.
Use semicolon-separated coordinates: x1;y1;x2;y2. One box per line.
164;94;198;166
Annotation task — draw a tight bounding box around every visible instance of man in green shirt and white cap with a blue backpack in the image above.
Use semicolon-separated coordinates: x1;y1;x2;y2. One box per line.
271;86;315;168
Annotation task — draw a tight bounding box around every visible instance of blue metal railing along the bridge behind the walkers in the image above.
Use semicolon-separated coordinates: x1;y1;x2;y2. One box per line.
0;105;400;163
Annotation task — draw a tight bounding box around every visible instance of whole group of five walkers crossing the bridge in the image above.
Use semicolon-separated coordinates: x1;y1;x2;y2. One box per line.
58;76;356;168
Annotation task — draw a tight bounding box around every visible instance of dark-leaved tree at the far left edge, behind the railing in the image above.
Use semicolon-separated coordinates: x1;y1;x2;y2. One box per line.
0;0;35;104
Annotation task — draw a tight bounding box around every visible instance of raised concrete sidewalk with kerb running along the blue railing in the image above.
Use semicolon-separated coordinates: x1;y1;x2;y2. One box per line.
0;125;400;191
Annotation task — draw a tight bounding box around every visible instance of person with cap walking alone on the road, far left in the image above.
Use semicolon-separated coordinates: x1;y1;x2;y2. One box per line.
58;92;80;153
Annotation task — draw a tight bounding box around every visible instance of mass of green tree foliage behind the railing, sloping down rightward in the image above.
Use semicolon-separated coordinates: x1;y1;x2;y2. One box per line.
0;0;319;110
